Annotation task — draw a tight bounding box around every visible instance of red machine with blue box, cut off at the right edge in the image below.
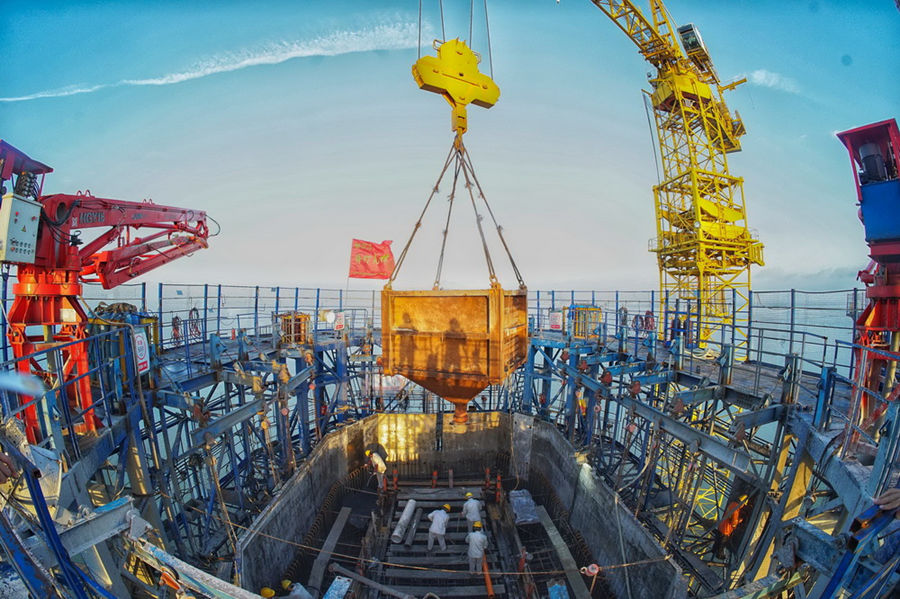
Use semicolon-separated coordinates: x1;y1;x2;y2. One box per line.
837;119;900;426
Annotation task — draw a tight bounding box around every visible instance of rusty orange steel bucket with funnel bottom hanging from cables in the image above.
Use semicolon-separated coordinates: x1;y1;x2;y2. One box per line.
381;285;528;423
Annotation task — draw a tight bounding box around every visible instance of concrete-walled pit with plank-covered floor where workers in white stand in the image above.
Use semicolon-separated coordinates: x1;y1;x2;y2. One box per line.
237;412;686;599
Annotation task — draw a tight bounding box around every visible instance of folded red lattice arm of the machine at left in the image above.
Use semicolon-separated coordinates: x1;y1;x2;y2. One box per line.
36;193;209;289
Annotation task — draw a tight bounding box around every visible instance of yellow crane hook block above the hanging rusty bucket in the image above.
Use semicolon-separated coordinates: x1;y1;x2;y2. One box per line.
412;39;500;135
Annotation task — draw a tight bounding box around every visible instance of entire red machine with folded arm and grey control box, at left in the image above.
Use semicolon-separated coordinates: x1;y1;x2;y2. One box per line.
0;140;209;443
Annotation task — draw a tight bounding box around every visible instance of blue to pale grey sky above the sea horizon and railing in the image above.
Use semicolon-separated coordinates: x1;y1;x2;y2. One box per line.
0;0;900;290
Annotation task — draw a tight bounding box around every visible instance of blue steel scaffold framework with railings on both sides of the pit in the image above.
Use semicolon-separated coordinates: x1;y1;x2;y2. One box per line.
0;285;900;597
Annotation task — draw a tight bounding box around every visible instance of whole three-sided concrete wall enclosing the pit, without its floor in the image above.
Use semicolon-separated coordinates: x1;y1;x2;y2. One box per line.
238;412;686;599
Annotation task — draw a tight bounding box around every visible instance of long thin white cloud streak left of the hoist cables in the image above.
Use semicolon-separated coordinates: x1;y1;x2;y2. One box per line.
0;23;418;102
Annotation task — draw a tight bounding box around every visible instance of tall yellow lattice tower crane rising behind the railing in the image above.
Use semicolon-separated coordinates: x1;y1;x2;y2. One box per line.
591;0;763;355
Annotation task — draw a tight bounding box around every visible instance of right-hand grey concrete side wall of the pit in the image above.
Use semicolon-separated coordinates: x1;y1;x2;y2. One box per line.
510;416;687;599
